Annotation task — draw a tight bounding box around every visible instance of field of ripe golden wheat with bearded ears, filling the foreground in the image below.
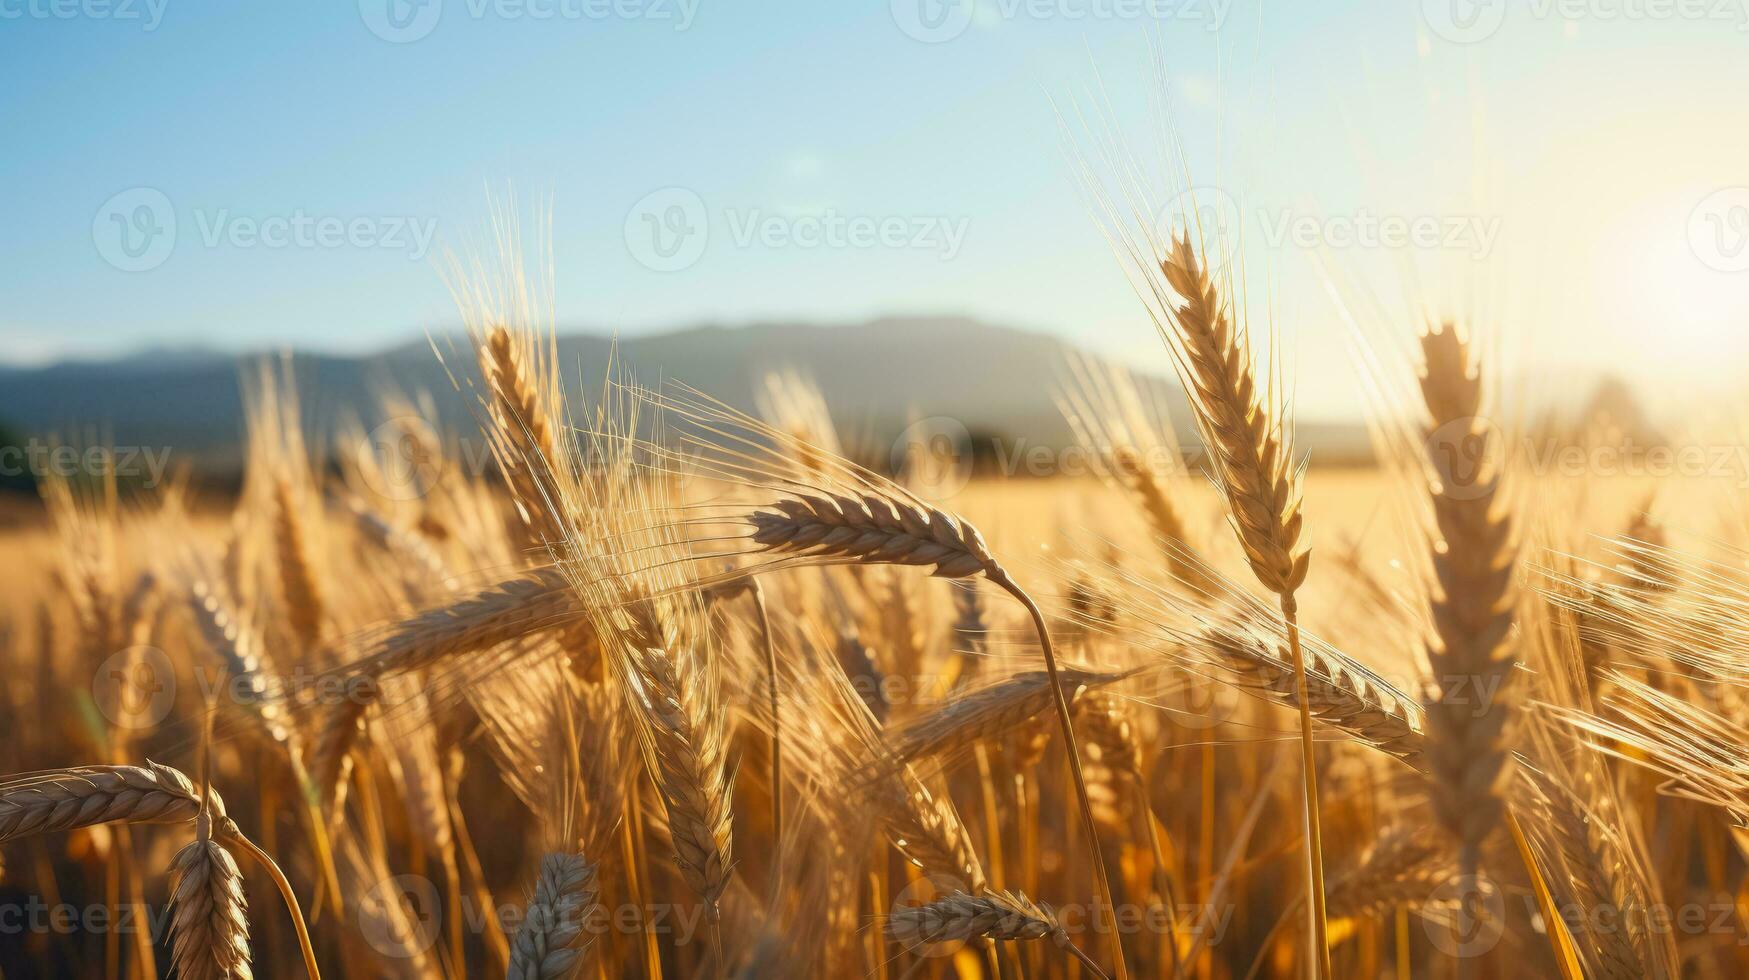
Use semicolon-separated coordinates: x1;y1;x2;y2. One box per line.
0;240;1749;980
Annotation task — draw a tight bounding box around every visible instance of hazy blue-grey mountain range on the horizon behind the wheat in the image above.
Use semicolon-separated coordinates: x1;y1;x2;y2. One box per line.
0;317;1366;467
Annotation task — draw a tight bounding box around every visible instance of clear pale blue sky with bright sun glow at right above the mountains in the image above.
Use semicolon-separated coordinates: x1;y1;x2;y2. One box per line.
0;0;1749;417
